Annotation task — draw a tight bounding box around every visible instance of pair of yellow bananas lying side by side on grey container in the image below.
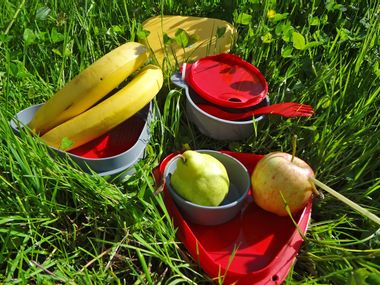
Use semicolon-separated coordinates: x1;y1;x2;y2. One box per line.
29;42;163;151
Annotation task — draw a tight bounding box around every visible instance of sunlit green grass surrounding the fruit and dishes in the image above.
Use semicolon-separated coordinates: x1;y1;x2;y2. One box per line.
0;0;380;285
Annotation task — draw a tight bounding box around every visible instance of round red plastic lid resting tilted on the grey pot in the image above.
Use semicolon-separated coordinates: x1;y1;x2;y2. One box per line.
182;53;268;108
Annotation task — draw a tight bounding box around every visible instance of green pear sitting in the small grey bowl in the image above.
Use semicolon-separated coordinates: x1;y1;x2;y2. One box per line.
171;150;230;206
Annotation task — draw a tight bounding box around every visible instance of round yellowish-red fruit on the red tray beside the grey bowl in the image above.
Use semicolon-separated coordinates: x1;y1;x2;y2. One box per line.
251;152;315;216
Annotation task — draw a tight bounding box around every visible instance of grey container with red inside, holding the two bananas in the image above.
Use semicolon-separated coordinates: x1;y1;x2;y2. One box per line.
10;102;152;177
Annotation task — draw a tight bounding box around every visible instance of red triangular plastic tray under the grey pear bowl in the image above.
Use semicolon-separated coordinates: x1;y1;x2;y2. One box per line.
155;151;312;285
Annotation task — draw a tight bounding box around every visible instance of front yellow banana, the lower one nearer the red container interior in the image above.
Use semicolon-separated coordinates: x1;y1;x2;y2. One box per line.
41;65;163;151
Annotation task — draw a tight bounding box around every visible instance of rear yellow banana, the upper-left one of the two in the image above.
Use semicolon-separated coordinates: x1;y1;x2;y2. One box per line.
29;42;148;134
